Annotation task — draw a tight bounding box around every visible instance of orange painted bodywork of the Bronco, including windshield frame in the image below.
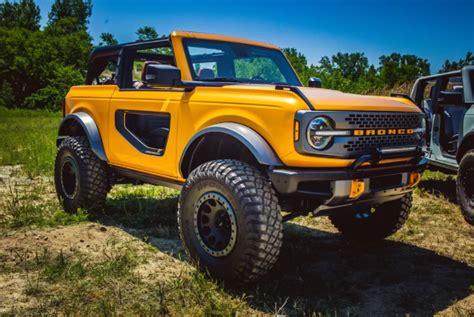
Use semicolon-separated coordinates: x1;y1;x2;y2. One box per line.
66;32;420;180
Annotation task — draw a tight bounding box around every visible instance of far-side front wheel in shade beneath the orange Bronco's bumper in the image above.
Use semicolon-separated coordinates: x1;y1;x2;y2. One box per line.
329;193;412;241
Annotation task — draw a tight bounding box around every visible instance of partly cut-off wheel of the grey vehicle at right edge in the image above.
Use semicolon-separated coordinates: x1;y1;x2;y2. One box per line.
456;150;474;225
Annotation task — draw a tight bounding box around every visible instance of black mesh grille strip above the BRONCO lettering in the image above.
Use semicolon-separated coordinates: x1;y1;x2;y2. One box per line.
345;113;421;129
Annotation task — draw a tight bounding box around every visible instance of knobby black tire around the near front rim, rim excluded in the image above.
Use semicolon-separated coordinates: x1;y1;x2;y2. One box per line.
178;160;283;284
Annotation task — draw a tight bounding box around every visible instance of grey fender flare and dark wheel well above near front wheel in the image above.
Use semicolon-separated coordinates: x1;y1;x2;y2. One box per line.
179;122;283;178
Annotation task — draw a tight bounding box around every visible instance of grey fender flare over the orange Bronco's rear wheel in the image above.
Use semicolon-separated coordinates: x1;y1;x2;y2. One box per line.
56;112;107;161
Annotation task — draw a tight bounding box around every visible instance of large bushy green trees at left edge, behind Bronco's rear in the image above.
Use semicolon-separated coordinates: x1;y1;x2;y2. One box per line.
0;1;92;109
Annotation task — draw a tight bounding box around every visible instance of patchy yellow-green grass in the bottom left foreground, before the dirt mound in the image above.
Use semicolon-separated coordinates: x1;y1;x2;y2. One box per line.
0;245;249;316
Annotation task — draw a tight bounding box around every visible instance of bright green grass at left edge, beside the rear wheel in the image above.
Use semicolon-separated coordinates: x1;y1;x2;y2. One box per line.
0;108;61;177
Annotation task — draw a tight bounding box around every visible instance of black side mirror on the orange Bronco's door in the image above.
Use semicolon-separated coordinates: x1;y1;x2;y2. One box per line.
143;63;181;87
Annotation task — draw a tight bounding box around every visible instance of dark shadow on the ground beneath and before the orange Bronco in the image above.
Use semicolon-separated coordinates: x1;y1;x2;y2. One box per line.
91;194;474;316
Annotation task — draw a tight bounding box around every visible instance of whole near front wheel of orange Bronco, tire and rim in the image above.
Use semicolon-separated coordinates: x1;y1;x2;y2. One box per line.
178;160;283;283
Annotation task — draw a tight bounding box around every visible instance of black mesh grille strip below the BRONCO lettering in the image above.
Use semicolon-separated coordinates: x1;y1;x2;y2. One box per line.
344;134;419;152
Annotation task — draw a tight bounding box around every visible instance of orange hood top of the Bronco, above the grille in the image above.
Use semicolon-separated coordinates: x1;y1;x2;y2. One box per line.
300;87;420;112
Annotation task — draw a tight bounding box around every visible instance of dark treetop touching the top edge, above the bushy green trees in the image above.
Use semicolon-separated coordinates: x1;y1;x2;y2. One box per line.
48;0;92;28
